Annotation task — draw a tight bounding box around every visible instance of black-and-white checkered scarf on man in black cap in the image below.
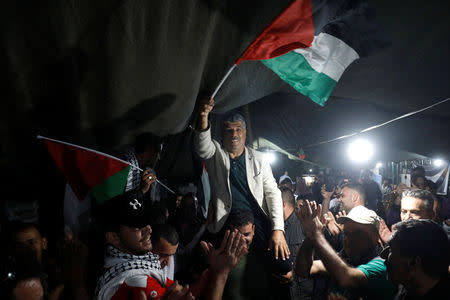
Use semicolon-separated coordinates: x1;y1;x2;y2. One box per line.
95;245;166;299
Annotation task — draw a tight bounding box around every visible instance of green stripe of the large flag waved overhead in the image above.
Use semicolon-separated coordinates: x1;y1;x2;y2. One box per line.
261;51;336;106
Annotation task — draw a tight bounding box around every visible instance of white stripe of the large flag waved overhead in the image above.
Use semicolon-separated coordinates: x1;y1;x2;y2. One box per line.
294;33;359;81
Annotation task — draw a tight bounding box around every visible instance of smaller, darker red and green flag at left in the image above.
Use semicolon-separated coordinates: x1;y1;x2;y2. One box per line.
38;136;132;204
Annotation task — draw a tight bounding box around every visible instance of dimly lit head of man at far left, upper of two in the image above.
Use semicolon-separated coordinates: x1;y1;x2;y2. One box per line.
8;222;47;264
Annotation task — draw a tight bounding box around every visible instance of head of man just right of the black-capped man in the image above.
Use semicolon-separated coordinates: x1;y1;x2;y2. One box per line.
152;224;179;268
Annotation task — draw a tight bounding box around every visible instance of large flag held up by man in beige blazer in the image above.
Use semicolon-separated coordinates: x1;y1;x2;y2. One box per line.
236;0;388;106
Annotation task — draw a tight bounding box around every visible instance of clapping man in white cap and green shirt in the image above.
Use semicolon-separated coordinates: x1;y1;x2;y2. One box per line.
296;201;396;299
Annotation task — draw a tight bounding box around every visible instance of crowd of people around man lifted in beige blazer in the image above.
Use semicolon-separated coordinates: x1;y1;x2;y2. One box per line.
0;99;450;300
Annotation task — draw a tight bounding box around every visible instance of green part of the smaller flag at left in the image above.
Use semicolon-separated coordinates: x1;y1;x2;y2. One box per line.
90;166;131;205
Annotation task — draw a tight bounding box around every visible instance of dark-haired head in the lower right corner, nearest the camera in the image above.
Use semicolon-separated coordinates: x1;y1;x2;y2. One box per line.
381;219;450;290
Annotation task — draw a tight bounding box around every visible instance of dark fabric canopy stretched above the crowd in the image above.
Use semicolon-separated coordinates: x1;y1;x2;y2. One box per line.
0;0;450;192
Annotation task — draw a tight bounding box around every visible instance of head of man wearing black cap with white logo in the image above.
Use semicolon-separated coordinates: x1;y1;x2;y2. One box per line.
101;194;152;255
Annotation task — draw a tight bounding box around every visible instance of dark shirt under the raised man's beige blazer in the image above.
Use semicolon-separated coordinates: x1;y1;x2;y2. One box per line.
230;151;259;212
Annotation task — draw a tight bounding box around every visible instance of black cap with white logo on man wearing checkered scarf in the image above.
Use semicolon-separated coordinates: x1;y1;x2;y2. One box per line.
100;193;150;228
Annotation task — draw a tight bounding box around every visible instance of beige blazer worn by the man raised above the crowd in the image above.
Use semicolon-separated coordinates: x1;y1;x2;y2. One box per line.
194;128;284;233
